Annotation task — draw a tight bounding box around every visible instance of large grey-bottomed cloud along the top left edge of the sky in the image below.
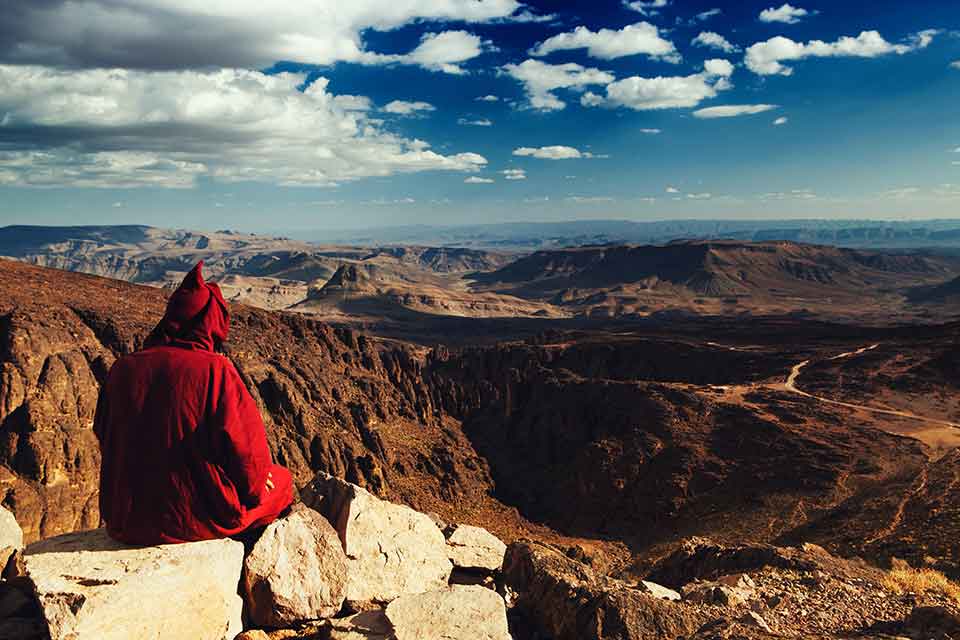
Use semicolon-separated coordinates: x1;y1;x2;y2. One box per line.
0;0;532;70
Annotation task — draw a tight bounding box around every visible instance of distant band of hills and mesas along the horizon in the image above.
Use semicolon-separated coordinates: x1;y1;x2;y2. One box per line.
0;226;960;336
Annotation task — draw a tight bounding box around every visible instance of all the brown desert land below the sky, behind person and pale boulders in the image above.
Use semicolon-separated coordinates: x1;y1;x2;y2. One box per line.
0;222;960;640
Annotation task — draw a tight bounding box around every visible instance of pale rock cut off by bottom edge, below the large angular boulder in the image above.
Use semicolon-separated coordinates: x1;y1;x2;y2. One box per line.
386;586;510;640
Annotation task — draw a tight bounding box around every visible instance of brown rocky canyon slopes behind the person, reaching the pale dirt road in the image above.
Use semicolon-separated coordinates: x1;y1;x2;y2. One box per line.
0;261;960;584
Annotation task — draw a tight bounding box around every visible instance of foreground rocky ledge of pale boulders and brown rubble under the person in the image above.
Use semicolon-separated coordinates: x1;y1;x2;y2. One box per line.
0;474;960;640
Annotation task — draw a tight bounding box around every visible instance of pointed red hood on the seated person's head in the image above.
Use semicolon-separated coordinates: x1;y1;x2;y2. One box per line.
145;260;230;351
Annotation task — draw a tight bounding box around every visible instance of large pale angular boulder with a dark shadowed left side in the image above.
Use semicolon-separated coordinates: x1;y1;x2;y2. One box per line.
301;473;453;606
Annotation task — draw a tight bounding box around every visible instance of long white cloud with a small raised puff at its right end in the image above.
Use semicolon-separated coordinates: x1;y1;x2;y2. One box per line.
580;59;733;111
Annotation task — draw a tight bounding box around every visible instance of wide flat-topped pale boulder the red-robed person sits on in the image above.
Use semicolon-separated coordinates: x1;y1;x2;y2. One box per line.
23;529;243;640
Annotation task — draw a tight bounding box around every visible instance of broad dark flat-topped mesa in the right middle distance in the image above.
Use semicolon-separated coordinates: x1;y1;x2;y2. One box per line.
475;240;960;319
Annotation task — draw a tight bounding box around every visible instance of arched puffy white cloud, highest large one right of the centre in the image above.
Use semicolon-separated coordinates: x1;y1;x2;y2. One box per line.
530;22;681;62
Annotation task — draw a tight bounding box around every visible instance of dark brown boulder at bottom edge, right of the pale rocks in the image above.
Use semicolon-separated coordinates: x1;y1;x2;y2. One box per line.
503;541;709;640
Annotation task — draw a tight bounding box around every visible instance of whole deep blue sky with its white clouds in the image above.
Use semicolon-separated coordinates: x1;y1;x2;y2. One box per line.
0;0;960;231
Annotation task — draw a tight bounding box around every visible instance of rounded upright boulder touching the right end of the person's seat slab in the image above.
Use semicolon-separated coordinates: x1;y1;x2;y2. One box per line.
243;504;347;627
